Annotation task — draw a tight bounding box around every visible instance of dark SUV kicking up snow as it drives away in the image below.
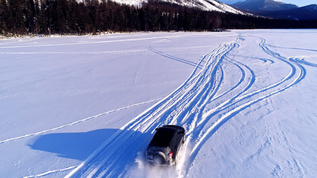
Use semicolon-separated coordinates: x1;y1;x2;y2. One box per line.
146;125;185;166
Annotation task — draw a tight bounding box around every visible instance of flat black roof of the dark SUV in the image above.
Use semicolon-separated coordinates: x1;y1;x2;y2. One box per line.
150;128;175;147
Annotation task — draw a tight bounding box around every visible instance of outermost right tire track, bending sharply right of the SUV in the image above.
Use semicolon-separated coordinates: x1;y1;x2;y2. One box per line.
187;36;306;175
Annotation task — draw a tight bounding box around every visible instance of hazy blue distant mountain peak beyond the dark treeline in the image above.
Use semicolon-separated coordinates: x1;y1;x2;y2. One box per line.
232;0;298;12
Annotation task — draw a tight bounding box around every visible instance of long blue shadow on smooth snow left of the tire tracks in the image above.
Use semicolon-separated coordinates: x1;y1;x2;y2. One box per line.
28;129;134;160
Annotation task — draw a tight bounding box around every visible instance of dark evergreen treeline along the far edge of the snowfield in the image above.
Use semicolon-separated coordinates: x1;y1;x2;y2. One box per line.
0;0;317;36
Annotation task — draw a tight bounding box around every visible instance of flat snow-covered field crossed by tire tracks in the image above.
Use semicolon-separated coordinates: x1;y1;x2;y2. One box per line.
0;30;317;177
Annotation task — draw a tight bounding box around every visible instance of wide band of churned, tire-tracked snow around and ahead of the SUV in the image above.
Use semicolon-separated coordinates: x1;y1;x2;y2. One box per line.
67;34;313;177
